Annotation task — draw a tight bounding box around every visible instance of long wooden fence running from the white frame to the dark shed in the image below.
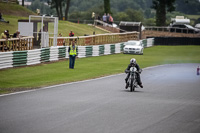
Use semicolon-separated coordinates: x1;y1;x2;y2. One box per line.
49;32;139;46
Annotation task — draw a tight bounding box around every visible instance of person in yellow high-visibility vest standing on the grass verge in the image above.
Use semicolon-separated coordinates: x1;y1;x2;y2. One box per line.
68;41;78;69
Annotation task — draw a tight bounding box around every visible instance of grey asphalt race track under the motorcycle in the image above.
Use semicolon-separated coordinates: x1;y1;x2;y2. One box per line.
0;64;200;133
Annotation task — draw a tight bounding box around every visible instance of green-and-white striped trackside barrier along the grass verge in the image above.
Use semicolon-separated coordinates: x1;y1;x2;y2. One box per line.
0;38;154;69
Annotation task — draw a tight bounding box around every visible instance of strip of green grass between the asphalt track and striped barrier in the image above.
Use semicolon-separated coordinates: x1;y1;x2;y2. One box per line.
0;46;200;94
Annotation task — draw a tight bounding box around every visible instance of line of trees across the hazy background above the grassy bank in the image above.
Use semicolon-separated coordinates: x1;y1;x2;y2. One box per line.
25;0;200;26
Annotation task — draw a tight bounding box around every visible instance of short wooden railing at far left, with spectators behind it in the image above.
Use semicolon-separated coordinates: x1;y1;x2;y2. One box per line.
0;36;34;52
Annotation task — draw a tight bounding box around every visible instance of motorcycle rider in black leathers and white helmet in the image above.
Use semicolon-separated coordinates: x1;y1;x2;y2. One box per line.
125;58;143;89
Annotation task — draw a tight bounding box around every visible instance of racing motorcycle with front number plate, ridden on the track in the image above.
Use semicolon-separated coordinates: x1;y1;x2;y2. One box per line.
126;67;142;92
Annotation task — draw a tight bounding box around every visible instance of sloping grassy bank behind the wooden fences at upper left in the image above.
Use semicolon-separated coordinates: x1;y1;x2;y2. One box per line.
0;3;106;37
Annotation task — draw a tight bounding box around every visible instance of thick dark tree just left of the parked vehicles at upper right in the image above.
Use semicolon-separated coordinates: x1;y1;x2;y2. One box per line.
152;0;176;26
